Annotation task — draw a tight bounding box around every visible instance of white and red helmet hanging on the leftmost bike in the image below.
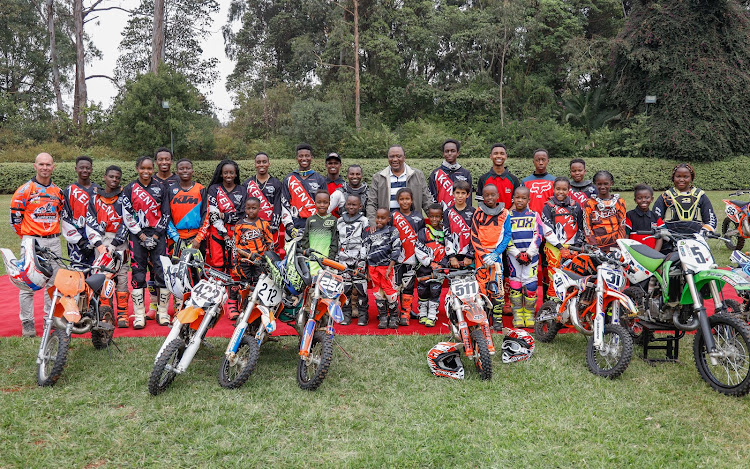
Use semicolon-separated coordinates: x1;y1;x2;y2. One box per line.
0;237;52;291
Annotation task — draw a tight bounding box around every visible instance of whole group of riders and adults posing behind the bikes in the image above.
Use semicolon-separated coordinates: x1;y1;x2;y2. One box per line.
10;143;716;337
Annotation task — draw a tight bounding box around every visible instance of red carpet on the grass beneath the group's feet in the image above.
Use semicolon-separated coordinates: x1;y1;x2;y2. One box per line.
0;275;741;337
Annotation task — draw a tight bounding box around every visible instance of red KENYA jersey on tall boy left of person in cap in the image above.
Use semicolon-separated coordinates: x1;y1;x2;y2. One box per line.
281;170;328;229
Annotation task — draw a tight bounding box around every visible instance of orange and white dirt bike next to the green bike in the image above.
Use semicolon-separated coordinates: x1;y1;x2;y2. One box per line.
534;247;637;379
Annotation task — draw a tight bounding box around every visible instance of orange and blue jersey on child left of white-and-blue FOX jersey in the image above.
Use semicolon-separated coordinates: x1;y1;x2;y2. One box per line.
471;203;510;265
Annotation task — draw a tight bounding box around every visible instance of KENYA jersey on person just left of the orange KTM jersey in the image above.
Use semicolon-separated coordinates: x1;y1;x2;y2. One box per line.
120;178;169;236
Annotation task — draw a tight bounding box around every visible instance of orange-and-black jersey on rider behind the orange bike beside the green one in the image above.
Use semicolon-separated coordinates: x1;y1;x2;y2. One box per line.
583;194;627;251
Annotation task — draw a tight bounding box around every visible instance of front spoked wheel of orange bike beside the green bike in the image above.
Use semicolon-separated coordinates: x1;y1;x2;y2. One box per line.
586;324;633;379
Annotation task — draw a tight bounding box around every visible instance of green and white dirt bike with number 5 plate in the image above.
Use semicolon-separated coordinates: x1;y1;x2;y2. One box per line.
617;229;750;396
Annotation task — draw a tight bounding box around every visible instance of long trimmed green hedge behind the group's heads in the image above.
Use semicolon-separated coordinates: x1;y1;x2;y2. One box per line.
0;156;750;194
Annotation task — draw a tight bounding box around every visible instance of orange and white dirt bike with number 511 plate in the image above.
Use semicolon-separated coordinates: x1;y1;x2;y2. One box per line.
417;266;502;380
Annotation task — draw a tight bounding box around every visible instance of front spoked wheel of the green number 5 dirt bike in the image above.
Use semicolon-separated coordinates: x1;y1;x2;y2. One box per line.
693;313;750;396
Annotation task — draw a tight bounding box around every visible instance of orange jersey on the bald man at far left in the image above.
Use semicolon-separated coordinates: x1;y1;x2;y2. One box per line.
10;178;63;236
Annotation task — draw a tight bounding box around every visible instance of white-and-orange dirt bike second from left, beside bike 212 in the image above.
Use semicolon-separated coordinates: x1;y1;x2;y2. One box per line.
148;256;235;396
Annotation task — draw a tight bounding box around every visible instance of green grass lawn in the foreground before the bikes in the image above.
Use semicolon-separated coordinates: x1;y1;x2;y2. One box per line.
0;334;750;468
